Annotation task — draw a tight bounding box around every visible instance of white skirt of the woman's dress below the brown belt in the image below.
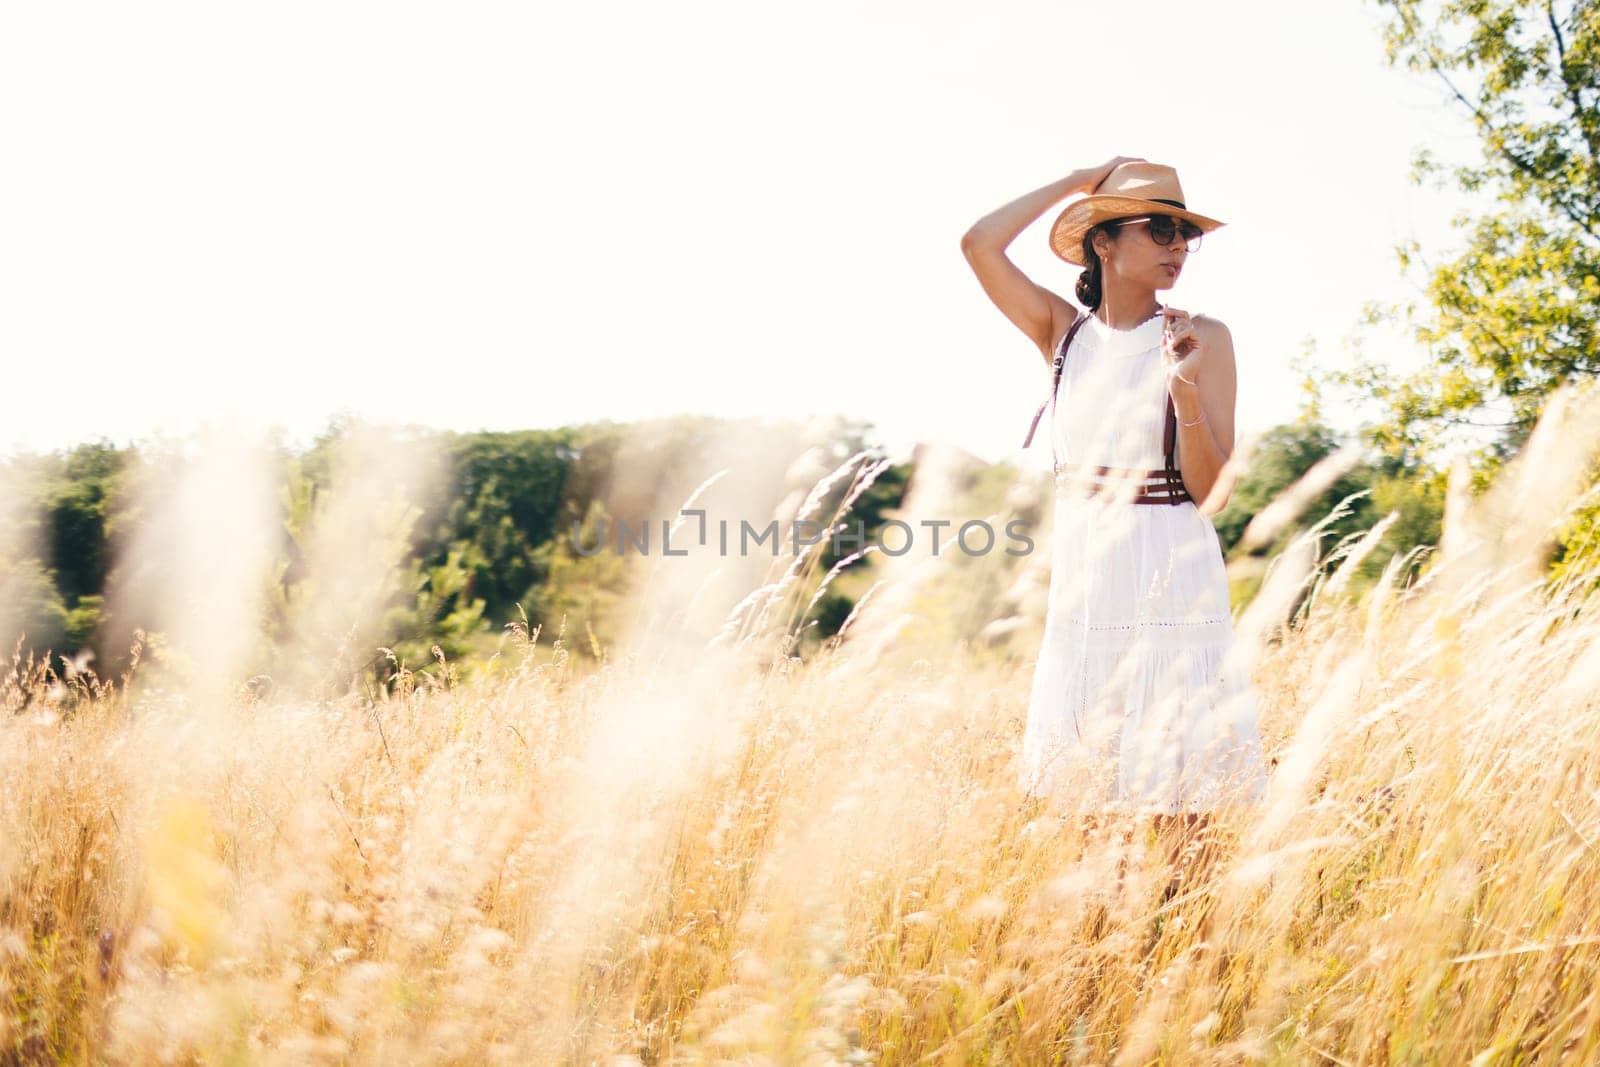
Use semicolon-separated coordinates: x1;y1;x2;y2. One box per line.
1018;491;1267;814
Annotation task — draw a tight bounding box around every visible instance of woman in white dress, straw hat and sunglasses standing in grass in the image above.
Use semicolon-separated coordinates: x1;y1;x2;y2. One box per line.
962;157;1267;893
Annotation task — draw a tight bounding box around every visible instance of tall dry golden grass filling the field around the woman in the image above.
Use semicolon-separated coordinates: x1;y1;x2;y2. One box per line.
0;385;1600;1064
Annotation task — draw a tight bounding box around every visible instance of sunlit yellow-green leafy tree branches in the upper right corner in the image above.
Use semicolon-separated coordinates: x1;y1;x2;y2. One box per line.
1331;0;1600;466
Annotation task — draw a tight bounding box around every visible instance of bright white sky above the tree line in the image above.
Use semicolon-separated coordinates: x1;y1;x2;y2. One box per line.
0;0;1472;464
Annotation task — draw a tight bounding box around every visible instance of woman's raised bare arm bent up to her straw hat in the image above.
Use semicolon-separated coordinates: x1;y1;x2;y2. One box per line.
962;155;1138;363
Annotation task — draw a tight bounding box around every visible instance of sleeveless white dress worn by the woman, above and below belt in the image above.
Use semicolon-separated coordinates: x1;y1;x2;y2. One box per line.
1019;315;1267;814
